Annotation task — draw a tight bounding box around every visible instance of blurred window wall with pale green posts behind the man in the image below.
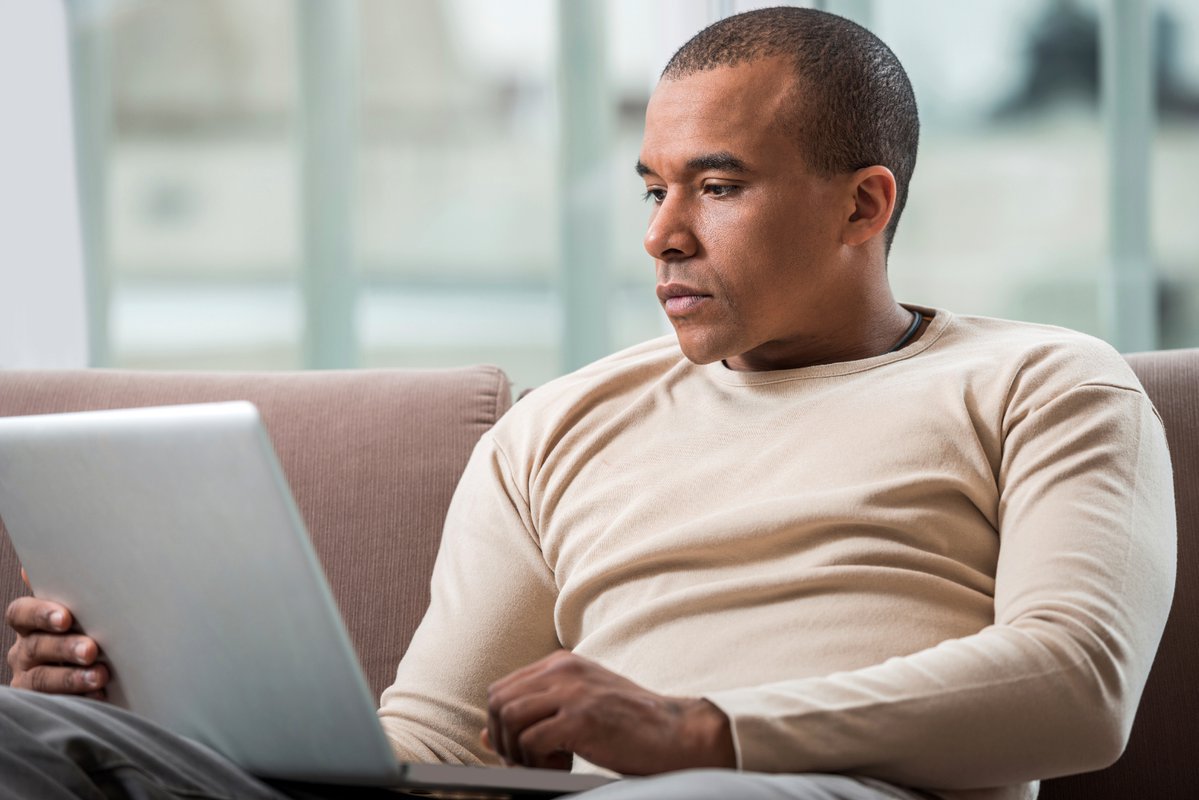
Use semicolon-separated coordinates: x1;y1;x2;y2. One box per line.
0;0;1199;386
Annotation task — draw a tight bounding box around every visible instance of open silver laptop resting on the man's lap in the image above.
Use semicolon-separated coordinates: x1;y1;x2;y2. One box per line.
0;402;608;798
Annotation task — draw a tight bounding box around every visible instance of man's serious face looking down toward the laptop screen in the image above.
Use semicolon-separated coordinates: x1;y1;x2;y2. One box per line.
638;59;854;369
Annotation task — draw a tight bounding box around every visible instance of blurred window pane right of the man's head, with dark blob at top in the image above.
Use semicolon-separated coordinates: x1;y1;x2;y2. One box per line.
873;0;1107;335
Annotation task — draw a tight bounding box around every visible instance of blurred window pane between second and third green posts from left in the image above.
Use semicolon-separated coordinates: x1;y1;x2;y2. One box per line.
357;0;559;385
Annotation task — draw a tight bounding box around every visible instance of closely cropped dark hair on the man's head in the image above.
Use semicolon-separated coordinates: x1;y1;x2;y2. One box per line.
662;7;920;252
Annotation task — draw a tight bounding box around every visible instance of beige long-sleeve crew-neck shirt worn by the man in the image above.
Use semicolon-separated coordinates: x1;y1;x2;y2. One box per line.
380;309;1175;799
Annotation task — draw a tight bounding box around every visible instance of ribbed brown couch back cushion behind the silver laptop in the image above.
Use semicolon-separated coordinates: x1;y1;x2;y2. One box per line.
0;367;511;697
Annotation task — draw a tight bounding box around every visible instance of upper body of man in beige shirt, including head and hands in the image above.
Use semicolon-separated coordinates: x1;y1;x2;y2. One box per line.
0;8;1174;800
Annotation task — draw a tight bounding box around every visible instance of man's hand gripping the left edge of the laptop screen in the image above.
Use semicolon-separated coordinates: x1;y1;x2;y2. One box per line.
5;597;108;699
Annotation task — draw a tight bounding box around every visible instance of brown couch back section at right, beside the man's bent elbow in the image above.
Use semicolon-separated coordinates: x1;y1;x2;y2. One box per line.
1041;349;1199;800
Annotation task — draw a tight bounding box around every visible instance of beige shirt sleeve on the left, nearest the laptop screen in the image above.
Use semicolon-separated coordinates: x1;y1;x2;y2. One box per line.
379;433;560;764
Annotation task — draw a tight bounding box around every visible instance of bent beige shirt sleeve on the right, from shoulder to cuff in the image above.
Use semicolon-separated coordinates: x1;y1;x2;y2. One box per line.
707;384;1175;789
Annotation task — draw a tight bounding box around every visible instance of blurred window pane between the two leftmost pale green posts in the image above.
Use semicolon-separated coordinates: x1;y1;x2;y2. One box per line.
103;0;302;368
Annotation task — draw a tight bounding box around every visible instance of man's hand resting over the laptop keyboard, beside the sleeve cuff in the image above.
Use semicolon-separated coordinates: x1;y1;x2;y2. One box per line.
483;650;736;775
